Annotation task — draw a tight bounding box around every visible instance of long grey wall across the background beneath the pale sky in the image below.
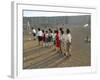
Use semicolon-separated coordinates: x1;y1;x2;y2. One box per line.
23;15;91;28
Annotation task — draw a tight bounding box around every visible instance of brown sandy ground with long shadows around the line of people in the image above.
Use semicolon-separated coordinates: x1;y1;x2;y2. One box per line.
23;25;91;69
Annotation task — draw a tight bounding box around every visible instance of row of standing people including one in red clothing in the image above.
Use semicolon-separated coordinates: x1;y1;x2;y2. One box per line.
32;28;72;57
